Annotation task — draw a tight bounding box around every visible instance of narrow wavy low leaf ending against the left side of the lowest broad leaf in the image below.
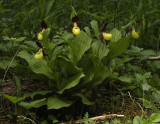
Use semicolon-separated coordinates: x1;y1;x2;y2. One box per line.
19;98;47;109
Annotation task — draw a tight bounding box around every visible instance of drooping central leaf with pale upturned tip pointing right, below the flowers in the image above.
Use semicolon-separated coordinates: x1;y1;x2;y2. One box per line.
57;72;85;94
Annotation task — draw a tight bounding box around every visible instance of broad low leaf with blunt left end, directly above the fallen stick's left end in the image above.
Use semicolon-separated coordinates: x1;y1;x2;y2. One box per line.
47;96;72;109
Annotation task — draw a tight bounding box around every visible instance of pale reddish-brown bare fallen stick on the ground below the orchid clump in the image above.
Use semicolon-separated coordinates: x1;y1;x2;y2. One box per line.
58;114;124;124
